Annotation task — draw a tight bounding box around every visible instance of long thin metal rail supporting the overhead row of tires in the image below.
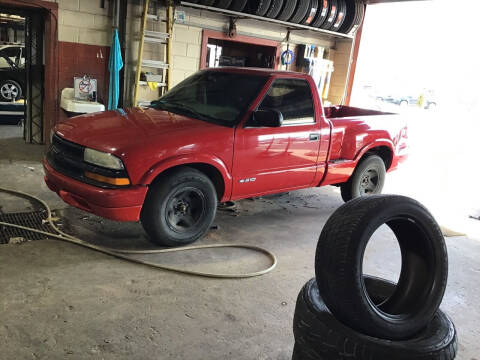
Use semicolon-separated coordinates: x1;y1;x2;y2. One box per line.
180;1;354;39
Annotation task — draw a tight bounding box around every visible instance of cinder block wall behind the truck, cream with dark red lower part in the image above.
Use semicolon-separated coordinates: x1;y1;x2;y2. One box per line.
48;0;352;106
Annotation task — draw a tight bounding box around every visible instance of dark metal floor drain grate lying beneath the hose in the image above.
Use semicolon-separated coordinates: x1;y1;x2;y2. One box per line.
0;211;54;244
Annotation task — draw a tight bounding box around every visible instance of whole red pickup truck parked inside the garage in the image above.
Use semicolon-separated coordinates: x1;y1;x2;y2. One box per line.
44;68;407;246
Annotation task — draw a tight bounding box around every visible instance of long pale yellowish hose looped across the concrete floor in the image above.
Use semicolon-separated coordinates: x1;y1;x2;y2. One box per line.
0;187;277;279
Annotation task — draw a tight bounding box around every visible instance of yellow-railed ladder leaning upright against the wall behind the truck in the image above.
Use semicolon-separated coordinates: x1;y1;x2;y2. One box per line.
133;0;173;107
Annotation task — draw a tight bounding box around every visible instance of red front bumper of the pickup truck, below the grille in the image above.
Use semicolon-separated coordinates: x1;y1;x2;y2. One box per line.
43;159;148;221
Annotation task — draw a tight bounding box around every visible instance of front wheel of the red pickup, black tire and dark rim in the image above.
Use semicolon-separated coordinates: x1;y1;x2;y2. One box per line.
140;167;217;246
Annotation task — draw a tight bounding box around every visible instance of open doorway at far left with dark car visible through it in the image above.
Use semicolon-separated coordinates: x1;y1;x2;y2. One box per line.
0;8;44;148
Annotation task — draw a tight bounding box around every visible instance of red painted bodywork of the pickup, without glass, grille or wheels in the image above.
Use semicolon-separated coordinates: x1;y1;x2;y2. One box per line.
45;68;407;221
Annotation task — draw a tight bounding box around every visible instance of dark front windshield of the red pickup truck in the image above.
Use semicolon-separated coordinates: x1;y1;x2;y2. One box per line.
152;71;267;127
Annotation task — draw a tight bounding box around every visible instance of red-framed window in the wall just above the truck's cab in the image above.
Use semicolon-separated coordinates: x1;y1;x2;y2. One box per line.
201;30;280;69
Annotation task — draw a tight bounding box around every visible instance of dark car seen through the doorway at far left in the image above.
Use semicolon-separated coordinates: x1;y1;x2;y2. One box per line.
0;45;25;102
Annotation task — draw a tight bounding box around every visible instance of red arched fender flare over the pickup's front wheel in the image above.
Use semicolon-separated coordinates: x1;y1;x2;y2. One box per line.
140;154;233;200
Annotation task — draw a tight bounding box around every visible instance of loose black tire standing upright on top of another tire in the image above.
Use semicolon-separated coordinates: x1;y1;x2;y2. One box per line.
315;195;448;340
